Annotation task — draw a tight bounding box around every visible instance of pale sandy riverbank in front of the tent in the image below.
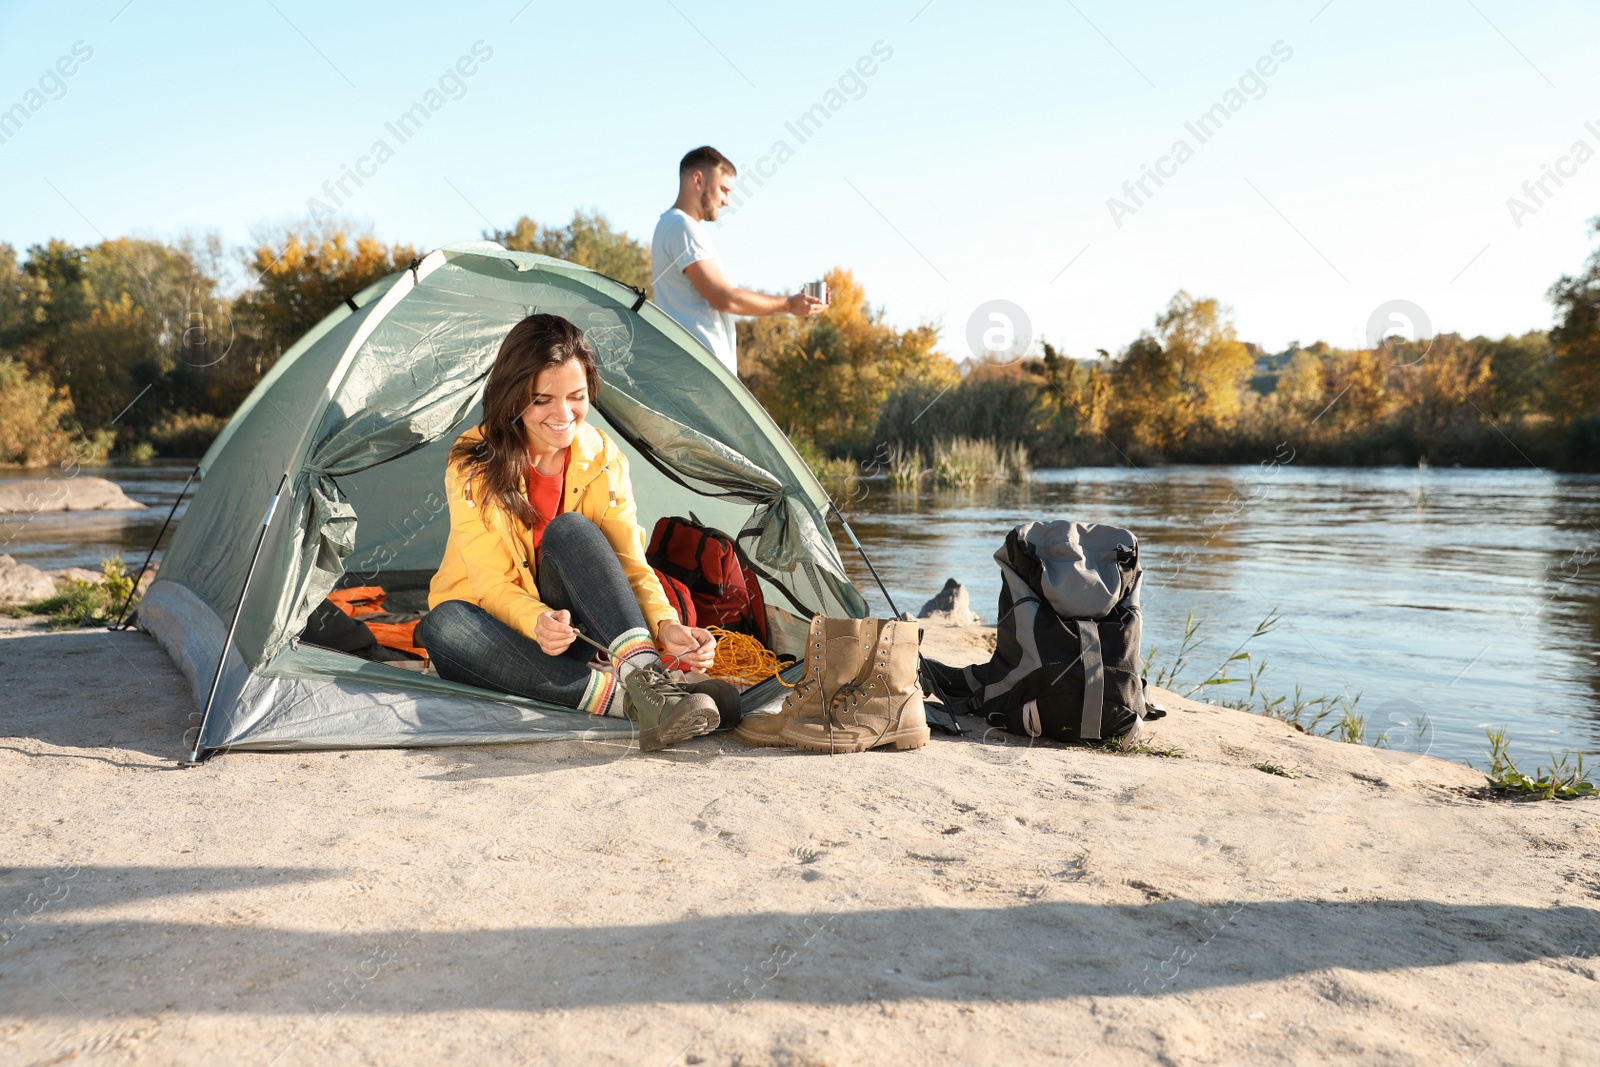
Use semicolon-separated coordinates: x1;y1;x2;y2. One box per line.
0;621;1600;1067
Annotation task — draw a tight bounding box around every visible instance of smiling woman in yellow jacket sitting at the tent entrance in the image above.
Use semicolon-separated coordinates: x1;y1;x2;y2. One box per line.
416;315;738;749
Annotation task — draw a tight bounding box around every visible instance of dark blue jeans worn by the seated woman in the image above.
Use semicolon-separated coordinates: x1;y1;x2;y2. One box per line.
416;512;648;709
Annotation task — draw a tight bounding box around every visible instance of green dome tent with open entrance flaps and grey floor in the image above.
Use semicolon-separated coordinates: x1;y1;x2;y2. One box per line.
134;242;866;758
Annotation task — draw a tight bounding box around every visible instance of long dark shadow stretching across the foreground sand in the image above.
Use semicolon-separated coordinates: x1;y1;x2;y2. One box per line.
0;865;1600;1017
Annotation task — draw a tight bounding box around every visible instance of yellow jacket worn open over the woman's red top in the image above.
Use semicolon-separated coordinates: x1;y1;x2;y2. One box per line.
427;422;678;638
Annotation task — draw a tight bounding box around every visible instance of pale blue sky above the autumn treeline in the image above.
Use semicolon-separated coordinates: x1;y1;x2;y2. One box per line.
0;0;1600;357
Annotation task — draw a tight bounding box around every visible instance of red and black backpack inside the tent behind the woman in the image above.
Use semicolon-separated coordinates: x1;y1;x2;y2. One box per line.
645;517;766;645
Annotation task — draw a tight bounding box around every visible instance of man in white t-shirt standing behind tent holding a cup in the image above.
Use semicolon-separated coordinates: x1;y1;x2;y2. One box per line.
650;144;827;374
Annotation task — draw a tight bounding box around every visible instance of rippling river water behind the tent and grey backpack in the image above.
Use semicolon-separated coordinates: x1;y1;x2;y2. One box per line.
0;462;1600;769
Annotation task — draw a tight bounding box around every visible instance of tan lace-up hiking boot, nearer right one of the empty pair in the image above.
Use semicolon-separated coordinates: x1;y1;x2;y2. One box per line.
779;619;931;752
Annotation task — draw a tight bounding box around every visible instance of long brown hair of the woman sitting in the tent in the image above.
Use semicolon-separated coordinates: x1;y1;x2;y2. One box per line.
450;314;600;526
